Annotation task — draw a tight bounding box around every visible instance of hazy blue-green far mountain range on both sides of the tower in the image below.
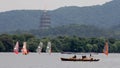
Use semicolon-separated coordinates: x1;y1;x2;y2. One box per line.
0;0;120;38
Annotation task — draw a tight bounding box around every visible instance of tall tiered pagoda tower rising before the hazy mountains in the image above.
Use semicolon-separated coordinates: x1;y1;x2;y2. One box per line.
40;11;51;30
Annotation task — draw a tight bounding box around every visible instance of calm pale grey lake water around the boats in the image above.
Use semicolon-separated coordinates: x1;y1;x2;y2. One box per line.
0;53;120;68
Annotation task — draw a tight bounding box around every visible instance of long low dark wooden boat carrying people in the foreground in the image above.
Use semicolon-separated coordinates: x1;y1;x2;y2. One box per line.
60;56;100;61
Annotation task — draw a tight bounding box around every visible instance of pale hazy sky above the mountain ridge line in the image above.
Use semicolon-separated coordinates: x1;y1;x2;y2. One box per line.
0;0;111;12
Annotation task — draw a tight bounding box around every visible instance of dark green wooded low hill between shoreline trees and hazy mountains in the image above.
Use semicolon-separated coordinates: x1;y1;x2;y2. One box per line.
8;24;120;39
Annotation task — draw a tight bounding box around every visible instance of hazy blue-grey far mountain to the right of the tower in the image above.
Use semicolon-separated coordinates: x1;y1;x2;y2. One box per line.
52;0;120;28
